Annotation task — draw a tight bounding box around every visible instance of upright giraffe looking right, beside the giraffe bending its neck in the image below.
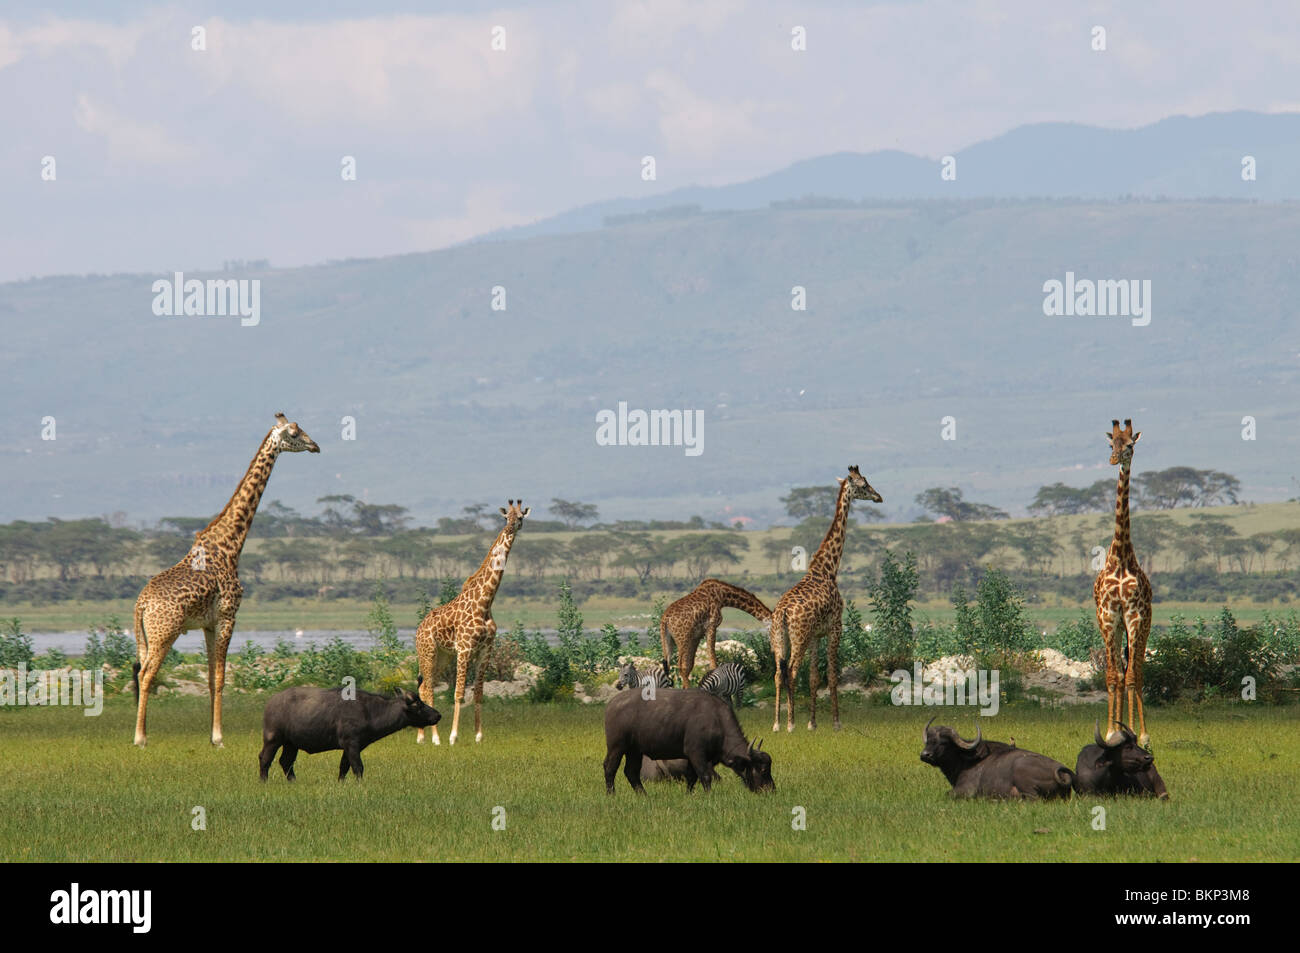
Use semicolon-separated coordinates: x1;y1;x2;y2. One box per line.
770;467;884;731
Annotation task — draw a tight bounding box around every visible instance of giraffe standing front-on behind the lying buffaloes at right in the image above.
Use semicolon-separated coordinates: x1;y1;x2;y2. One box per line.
1092;420;1151;748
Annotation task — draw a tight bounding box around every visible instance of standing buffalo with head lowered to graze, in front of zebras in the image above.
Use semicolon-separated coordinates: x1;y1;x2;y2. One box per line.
605;688;776;794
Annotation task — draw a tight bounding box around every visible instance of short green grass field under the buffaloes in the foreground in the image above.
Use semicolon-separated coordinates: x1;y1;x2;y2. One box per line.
0;693;1300;862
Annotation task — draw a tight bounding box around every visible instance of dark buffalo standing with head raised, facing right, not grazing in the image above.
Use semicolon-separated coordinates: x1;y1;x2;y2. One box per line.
257;679;442;781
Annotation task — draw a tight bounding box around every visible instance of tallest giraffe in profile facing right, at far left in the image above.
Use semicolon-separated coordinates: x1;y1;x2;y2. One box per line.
133;413;321;748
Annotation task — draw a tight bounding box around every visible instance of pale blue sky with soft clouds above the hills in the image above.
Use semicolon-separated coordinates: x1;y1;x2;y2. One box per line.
0;0;1300;281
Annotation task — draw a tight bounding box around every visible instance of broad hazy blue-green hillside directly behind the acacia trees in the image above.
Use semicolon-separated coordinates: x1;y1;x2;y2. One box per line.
0;189;1300;525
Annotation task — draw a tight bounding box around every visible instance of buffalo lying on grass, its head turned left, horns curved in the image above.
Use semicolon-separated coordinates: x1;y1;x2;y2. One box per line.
920;718;1074;801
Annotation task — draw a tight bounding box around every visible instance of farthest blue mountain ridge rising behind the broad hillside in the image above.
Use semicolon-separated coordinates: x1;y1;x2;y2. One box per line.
476;112;1300;241
